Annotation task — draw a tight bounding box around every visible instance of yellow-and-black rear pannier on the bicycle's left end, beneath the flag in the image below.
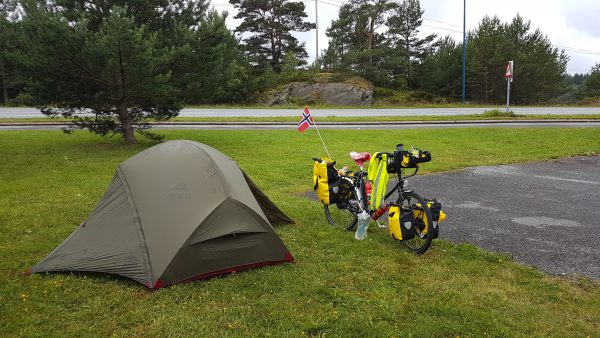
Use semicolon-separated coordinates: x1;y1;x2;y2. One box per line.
313;157;342;204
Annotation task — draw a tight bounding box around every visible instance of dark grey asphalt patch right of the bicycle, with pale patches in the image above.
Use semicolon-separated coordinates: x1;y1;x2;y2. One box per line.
409;156;600;279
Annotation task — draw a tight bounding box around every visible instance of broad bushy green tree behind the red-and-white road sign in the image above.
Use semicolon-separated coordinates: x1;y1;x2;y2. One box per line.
467;15;568;104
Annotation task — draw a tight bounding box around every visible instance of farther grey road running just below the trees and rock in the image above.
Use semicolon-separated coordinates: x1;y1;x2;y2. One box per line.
0;107;600;118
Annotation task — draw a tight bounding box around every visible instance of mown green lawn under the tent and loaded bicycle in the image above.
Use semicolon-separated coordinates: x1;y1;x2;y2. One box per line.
0;128;600;337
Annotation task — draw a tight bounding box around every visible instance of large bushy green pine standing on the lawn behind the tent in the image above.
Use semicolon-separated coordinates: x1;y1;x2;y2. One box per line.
19;6;181;144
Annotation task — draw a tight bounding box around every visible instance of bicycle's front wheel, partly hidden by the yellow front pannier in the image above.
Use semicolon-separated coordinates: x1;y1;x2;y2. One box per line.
402;191;433;254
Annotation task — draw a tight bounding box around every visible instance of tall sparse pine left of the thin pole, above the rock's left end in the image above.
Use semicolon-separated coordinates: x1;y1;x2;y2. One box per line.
230;0;315;72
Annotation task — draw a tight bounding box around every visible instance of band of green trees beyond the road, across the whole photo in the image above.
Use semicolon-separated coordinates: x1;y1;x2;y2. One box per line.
0;0;600;107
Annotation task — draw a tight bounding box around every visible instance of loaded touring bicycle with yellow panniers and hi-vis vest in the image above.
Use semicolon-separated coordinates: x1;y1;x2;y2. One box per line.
313;144;445;253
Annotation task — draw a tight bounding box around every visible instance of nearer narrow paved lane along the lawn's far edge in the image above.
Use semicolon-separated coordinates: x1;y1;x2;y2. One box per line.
0;120;600;130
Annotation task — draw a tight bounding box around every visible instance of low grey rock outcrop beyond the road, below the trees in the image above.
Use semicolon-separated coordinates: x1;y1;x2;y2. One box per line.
264;81;373;106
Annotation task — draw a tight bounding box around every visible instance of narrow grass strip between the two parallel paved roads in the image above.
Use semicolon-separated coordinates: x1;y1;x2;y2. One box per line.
0;110;600;123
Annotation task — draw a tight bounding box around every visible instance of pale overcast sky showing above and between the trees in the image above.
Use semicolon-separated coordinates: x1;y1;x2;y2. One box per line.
212;0;600;74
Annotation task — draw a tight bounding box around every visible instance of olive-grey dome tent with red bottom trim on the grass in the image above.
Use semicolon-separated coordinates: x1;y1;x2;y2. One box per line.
31;140;294;289
